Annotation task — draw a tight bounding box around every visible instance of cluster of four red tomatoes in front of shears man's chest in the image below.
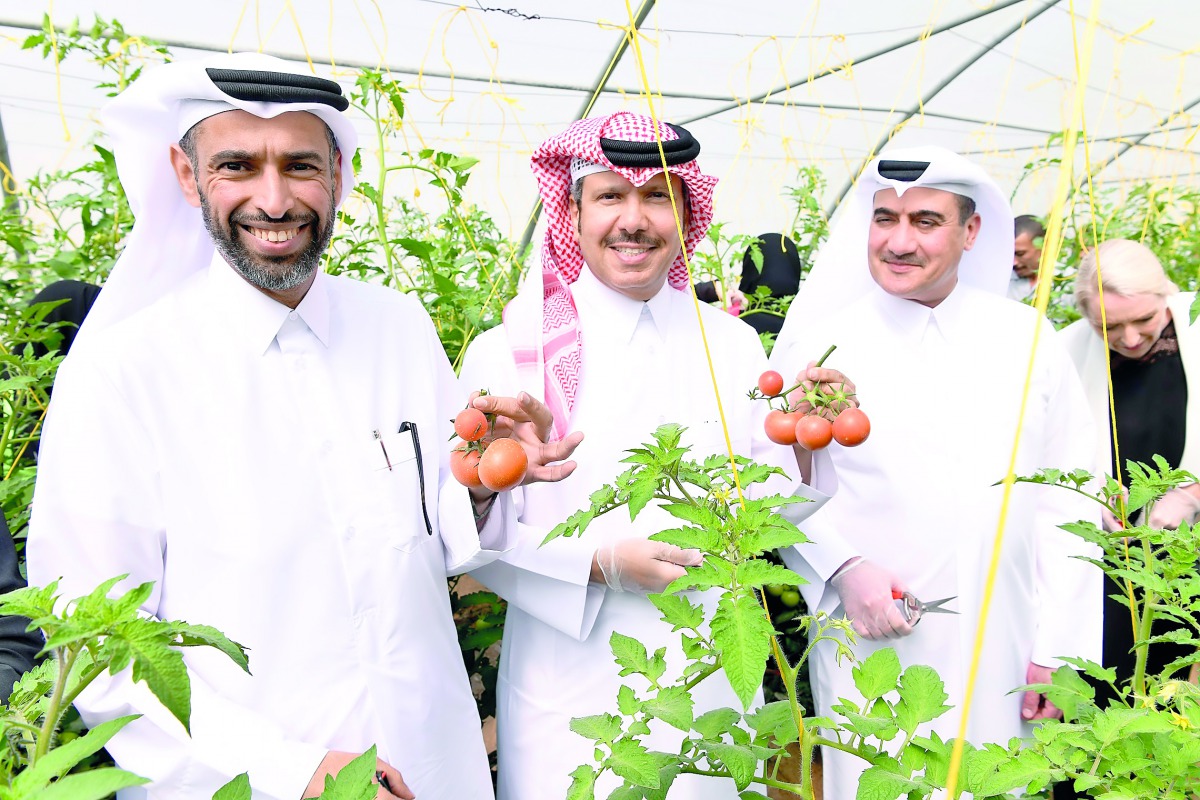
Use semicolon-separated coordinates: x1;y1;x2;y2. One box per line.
758;369;871;450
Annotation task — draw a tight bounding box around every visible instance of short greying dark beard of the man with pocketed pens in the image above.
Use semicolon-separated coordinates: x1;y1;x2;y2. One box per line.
200;192;336;291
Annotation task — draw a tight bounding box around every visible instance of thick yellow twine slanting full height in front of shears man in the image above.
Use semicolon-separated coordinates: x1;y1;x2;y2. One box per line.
946;0;1099;798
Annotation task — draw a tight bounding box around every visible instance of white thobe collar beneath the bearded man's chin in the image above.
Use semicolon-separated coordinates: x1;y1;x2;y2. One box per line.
209;253;329;355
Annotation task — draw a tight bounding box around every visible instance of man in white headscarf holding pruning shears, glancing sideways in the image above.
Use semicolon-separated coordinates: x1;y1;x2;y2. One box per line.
772;148;1100;800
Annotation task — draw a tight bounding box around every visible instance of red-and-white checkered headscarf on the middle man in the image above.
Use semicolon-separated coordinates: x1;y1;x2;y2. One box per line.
504;112;716;439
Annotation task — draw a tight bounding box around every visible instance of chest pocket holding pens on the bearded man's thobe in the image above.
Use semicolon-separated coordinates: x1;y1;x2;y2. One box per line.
360;422;437;553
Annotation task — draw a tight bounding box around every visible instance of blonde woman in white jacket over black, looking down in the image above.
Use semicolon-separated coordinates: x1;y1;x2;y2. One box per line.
1055;239;1200;798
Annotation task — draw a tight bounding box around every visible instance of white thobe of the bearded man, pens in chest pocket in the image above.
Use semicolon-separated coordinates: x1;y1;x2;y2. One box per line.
29;258;515;800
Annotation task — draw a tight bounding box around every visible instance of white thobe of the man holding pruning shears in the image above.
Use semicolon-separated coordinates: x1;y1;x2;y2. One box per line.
772;284;1100;800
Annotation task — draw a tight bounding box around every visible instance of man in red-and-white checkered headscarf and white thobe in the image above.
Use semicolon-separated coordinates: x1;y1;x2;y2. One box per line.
462;113;845;800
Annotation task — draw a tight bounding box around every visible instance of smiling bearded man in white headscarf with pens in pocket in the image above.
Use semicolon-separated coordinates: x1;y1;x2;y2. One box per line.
29;54;570;800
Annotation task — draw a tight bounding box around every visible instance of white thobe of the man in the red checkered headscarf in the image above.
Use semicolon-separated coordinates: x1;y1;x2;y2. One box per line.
462;269;832;800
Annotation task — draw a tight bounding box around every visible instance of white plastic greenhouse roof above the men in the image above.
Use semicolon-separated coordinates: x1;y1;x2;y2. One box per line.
0;0;1200;244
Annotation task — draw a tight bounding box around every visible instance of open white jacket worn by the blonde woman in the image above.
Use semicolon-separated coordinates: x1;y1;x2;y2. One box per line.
1062;291;1200;475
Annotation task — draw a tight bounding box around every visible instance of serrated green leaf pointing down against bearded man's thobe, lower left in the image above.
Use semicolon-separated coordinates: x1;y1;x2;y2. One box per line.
100;619;192;734
